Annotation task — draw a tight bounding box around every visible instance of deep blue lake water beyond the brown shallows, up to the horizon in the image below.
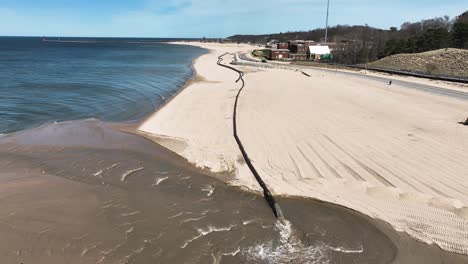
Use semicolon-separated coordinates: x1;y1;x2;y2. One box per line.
0;37;205;133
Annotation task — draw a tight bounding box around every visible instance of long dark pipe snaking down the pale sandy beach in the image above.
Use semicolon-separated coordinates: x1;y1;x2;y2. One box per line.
217;53;284;220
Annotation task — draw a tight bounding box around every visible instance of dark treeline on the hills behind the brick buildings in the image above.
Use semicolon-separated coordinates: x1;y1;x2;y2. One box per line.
229;12;468;64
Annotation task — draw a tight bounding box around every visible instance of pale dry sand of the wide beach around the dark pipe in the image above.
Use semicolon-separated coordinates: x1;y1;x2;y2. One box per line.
139;43;468;254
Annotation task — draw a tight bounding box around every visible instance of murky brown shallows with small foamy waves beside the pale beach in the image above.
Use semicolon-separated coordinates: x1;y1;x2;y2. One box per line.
0;120;468;264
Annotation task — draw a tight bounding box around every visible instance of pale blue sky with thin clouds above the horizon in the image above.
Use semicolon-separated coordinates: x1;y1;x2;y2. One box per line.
0;0;468;37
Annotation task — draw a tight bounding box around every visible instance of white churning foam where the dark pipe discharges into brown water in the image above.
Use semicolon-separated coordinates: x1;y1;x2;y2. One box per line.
242;220;329;264
